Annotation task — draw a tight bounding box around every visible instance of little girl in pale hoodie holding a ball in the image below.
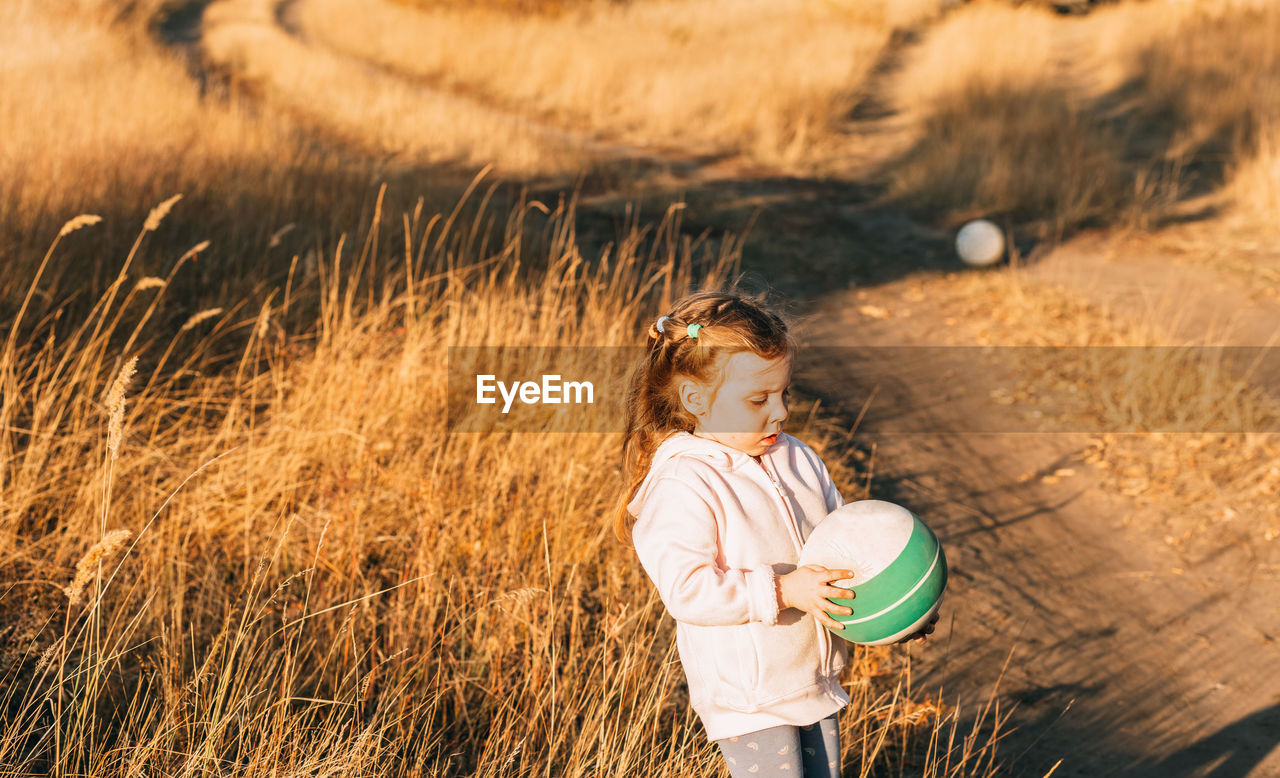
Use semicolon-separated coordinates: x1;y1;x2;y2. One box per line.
616;292;932;778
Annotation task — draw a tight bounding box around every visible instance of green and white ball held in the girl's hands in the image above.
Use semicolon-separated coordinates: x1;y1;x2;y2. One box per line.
800;500;947;646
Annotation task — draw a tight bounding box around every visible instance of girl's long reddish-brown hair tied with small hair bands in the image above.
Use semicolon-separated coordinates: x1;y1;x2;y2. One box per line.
613;290;797;541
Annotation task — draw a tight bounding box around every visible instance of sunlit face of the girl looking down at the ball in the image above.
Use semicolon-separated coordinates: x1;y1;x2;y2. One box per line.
680;352;791;457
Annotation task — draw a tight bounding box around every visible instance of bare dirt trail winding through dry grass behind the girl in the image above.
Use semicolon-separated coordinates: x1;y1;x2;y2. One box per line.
157;0;1280;778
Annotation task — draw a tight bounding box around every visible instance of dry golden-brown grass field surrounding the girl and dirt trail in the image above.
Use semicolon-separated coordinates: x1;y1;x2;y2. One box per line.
0;0;1280;778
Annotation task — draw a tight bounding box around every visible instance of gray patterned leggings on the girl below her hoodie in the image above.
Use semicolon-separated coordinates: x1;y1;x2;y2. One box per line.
716;713;840;778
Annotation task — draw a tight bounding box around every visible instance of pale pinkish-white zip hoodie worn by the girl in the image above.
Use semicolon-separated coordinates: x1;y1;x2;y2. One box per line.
627;431;849;741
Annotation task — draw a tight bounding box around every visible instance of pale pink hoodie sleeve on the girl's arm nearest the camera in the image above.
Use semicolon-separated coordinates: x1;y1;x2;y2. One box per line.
631;476;778;627
